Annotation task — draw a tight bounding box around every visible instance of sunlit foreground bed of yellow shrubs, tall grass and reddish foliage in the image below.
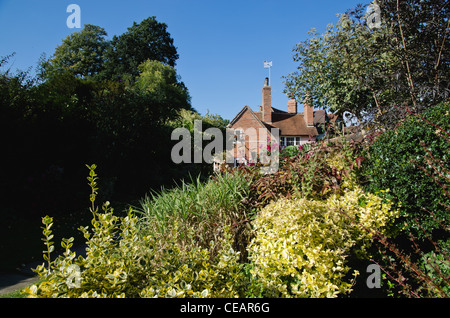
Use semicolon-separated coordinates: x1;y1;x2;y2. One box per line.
21;127;448;297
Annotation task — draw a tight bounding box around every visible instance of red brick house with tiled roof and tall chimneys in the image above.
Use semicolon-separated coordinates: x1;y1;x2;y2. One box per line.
228;78;335;165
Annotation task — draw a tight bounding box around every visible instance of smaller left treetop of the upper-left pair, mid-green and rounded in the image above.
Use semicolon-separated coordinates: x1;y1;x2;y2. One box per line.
41;24;109;79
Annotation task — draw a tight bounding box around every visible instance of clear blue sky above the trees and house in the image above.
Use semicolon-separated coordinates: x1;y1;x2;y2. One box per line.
0;0;370;119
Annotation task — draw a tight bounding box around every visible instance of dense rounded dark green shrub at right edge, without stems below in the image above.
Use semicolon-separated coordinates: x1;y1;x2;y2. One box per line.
363;102;450;235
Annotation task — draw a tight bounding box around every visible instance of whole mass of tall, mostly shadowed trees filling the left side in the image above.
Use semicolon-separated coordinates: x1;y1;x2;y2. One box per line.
0;17;229;219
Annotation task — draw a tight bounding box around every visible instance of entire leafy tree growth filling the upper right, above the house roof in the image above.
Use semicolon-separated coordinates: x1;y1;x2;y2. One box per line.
285;0;450;127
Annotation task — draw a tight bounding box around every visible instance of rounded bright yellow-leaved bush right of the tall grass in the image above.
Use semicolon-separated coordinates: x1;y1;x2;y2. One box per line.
249;188;398;297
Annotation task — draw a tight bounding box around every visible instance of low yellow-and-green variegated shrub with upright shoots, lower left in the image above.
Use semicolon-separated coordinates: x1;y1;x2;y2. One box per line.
24;166;246;298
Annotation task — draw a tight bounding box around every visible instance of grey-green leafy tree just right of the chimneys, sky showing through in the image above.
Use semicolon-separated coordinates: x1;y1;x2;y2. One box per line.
286;15;395;125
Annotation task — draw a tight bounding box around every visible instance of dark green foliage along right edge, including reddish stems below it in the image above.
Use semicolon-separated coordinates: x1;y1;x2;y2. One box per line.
363;102;450;297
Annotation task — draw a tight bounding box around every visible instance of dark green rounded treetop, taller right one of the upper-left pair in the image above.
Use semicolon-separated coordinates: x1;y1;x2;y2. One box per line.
104;17;178;80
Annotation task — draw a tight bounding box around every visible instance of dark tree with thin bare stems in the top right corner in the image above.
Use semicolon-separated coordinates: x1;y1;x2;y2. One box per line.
380;0;450;110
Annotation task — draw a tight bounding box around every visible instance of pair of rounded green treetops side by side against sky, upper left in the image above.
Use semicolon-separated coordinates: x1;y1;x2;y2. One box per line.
40;17;179;83
